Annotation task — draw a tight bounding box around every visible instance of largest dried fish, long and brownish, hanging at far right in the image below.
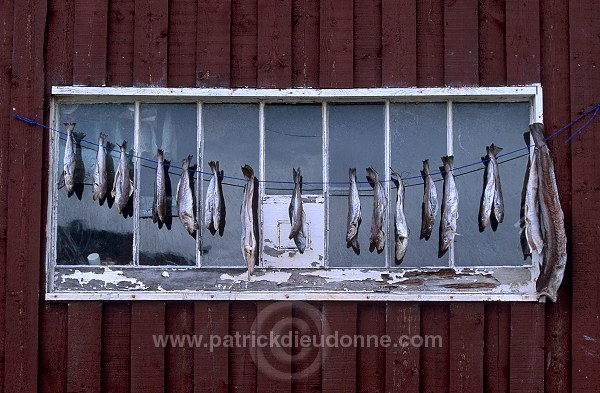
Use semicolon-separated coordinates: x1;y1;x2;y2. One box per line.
529;123;567;302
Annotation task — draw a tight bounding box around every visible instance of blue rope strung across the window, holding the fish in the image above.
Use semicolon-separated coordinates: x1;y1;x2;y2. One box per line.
13;103;600;185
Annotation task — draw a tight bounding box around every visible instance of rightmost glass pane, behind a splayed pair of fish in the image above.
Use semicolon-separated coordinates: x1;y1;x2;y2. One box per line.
453;103;529;266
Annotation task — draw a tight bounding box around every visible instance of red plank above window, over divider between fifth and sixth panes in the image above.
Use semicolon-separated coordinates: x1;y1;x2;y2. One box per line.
381;0;417;87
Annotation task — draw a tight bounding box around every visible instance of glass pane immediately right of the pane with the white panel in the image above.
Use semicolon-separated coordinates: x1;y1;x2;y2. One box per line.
328;104;389;267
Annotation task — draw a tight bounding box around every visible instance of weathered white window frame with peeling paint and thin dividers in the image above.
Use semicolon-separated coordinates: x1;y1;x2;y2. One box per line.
46;84;543;301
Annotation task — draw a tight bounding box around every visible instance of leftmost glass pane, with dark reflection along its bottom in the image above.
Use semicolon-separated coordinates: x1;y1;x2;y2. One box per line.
56;104;134;265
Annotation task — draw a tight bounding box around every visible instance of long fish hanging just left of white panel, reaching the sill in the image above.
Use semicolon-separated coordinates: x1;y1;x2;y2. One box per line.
241;164;258;281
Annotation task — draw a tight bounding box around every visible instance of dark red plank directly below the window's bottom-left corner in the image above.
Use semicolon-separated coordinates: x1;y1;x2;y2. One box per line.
38;303;68;393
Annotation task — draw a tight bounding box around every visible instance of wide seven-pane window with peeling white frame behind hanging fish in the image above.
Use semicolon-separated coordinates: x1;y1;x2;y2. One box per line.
46;85;542;301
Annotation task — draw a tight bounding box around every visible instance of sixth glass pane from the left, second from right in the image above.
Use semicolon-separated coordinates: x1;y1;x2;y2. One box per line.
389;103;448;267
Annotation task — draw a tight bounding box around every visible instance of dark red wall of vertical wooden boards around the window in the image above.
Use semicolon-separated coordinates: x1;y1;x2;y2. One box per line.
0;0;600;393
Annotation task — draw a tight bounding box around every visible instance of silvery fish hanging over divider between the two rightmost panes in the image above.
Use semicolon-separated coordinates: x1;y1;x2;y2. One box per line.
438;156;458;258
